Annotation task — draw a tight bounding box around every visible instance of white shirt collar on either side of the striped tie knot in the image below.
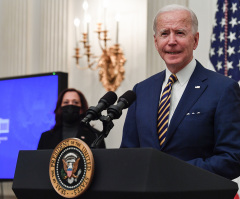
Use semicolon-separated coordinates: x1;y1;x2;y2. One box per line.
166;58;197;85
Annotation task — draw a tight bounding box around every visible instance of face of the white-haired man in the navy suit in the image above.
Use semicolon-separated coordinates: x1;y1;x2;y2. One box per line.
154;10;199;73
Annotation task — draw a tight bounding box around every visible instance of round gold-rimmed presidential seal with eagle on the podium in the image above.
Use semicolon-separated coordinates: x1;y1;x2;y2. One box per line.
49;138;94;198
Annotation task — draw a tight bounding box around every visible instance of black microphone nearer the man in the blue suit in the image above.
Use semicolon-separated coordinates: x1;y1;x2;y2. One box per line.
107;90;136;120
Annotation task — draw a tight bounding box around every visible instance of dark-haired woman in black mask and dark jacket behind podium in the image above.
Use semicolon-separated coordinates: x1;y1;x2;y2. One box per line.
38;88;105;149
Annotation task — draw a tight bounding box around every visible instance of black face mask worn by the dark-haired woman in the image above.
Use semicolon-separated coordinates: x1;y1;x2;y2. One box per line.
61;105;81;124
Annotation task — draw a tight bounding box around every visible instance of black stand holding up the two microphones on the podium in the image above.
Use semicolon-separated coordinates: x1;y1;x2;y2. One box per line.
91;115;114;149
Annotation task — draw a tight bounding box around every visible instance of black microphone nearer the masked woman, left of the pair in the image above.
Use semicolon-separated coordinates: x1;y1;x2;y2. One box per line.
81;91;117;123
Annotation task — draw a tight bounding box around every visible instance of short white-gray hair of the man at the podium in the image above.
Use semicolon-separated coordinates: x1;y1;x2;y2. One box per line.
153;4;198;35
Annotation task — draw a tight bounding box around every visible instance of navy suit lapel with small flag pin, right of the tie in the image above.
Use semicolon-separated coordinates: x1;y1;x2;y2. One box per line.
162;62;207;149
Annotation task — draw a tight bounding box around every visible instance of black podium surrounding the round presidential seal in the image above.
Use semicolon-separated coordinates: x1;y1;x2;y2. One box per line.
12;148;238;199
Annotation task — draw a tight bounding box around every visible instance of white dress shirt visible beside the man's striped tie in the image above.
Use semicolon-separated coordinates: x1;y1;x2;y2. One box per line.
160;58;197;125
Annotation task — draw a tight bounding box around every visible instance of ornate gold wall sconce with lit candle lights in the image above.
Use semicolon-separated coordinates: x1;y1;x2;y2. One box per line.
73;1;126;91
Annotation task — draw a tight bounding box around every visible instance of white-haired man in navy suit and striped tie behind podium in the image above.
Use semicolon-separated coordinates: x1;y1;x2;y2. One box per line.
121;5;240;179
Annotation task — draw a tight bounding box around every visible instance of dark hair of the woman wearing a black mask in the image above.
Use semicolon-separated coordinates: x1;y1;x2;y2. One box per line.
52;88;88;130
